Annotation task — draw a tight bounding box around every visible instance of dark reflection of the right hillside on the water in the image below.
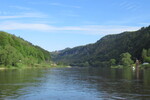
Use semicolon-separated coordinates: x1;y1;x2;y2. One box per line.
82;68;150;100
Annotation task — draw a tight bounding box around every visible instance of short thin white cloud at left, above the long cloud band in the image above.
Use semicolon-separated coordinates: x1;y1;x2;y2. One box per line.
0;13;47;19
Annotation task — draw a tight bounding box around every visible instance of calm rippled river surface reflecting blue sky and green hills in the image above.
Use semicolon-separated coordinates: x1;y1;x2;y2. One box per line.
0;68;150;100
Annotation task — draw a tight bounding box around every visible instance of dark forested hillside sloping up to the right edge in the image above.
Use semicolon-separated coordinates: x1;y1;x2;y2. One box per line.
52;26;150;67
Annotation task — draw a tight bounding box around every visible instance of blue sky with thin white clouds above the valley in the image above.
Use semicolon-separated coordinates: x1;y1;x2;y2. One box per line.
0;0;150;51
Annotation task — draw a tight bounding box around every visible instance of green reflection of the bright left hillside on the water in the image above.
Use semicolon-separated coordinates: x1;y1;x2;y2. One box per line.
0;69;47;98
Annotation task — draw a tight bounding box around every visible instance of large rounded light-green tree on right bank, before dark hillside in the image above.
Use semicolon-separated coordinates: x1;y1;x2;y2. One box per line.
120;52;134;66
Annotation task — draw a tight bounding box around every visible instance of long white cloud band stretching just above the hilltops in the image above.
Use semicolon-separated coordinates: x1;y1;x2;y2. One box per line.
0;22;140;35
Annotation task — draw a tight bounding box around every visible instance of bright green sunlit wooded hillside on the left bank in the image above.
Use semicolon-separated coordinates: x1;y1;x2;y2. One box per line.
0;31;51;67
